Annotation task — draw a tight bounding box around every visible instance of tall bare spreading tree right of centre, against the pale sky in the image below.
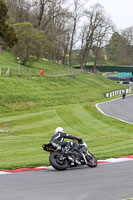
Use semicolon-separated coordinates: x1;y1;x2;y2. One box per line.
80;4;111;69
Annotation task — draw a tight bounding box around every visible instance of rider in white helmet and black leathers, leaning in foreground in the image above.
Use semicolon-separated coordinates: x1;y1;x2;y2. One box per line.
50;127;82;150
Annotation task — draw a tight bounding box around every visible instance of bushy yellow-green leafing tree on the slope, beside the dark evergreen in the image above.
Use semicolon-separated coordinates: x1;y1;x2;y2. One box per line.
12;22;49;65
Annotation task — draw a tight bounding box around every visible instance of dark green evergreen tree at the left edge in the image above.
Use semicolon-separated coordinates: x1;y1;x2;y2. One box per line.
0;0;17;53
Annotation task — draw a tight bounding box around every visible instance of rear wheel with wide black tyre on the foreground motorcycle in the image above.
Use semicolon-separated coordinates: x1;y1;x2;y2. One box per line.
49;151;68;171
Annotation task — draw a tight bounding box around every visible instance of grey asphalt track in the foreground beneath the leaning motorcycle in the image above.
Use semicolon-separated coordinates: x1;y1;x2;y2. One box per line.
0;161;133;200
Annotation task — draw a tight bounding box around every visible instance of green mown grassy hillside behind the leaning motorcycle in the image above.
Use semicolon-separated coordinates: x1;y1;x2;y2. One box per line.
0;52;133;169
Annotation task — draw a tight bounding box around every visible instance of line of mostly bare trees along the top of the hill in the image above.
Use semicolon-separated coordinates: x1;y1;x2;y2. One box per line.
0;0;133;69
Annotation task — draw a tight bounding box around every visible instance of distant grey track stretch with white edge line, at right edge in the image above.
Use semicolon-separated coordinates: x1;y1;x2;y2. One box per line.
97;95;133;124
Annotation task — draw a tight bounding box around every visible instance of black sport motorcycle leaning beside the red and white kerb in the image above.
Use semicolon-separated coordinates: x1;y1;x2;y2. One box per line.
42;141;97;170
